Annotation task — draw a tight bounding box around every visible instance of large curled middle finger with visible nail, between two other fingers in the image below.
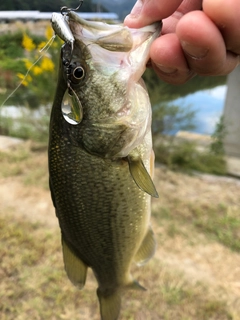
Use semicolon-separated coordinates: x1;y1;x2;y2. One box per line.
176;11;238;75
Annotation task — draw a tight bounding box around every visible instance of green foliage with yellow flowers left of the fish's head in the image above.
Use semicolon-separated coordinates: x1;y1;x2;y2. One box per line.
0;25;61;108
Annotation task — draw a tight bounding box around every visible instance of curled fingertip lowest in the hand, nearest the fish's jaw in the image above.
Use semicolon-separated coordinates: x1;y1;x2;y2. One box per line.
150;33;194;84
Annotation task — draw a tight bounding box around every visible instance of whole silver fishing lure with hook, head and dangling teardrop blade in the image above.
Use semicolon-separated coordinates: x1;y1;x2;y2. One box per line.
51;0;85;125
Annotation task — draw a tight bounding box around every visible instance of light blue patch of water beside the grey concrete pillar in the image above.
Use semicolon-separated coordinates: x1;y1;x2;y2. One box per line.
174;85;227;135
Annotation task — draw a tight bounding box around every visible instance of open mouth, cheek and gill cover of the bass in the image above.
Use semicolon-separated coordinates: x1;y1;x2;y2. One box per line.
62;12;162;157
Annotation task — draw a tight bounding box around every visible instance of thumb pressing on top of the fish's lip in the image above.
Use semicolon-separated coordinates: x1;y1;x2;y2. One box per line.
124;0;182;28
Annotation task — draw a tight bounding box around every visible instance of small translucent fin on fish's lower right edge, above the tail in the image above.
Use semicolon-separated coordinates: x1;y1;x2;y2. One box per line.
134;227;156;265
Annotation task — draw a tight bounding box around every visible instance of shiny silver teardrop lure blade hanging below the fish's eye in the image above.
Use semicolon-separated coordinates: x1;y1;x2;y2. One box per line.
61;89;83;125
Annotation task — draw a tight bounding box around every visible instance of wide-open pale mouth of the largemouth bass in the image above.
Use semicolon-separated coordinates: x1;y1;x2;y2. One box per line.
69;12;162;80
